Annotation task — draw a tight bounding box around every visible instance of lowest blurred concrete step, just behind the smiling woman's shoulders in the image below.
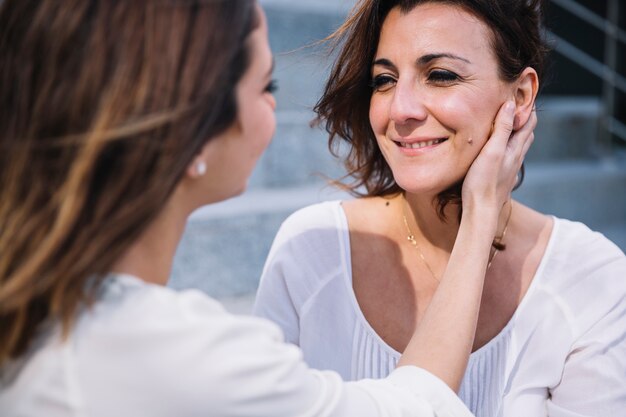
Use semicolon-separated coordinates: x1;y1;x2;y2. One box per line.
171;160;626;298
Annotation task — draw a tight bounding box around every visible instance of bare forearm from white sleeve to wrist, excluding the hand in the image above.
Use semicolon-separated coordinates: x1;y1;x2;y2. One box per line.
398;209;498;391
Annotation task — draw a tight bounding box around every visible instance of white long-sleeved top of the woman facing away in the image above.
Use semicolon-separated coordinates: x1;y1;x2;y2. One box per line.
0;276;470;417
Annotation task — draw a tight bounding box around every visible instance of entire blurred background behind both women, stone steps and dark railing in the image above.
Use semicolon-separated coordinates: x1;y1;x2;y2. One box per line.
170;0;626;313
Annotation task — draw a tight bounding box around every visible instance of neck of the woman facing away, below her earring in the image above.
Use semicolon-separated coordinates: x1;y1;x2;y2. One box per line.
112;190;191;285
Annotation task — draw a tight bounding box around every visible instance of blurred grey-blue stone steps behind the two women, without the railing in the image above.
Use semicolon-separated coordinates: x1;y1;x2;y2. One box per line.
170;0;626;312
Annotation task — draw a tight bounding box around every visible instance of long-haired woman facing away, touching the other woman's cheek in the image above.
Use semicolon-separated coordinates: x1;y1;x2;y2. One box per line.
0;0;534;417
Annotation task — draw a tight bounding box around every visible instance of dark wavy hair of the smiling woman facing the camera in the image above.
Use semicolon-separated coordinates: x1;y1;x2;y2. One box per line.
315;0;549;219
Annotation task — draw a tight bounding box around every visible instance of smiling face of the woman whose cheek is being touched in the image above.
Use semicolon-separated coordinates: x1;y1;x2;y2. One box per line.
370;3;513;194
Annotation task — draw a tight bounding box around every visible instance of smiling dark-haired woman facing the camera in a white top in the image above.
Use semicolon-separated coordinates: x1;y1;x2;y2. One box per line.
255;0;626;417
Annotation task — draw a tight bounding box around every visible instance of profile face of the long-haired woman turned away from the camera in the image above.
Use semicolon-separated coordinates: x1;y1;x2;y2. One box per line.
205;6;276;202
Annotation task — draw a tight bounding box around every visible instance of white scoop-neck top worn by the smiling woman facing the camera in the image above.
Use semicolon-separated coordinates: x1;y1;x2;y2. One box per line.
255;201;626;417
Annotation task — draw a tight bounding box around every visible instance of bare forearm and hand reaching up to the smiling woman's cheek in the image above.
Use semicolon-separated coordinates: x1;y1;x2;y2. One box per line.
398;101;537;391
